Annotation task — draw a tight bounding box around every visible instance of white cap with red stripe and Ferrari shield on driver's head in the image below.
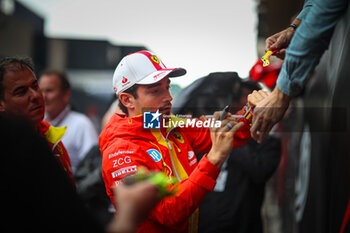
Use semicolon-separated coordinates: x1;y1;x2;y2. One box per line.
113;51;186;95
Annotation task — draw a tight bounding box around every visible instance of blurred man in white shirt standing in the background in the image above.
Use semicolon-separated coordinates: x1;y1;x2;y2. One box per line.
39;70;97;172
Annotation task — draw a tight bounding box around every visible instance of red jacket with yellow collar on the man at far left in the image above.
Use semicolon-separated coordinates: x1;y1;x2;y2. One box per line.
38;121;75;187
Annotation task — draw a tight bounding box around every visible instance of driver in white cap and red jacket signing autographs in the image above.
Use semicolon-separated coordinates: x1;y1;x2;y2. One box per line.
99;51;266;233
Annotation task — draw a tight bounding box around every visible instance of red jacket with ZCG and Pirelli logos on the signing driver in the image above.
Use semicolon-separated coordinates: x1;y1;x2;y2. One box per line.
99;110;250;233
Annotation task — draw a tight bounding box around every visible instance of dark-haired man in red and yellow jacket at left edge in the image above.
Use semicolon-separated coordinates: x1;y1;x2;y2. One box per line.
0;57;74;183
